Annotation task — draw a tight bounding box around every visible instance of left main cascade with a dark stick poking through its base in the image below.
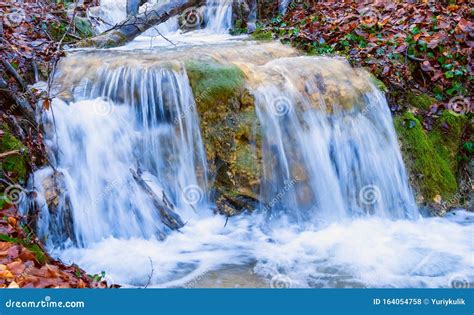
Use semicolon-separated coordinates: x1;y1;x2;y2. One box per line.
25;66;207;247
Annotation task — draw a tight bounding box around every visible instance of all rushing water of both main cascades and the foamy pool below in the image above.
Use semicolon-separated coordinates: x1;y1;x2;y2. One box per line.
21;3;474;287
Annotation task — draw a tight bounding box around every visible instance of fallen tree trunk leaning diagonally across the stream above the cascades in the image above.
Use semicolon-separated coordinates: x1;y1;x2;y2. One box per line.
77;0;205;48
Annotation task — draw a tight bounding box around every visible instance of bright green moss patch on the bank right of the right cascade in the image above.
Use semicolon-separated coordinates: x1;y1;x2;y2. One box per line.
395;112;457;199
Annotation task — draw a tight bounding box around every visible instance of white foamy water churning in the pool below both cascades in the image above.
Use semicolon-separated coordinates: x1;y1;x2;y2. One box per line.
60;212;474;288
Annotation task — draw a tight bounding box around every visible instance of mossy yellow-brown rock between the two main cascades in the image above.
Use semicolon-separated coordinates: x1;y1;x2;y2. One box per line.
186;59;262;211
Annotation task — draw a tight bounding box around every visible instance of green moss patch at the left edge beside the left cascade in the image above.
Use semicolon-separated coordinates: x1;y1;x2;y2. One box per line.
0;125;27;182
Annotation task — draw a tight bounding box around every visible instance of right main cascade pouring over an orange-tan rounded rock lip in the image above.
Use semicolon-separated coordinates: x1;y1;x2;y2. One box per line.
250;57;419;224
